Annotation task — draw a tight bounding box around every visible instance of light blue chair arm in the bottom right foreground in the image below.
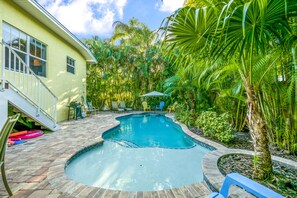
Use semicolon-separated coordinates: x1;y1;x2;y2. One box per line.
207;173;283;198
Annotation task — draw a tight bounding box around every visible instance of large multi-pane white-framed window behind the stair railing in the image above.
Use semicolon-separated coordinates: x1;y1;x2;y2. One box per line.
2;23;46;77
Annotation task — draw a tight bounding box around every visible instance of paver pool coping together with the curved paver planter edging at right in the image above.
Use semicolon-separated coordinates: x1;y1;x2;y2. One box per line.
47;112;297;197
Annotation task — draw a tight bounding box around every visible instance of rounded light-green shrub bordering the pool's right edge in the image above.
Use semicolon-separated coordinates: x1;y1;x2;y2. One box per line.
195;111;235;143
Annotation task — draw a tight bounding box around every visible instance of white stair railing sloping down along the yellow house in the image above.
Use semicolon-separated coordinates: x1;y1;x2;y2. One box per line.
0;42;58;124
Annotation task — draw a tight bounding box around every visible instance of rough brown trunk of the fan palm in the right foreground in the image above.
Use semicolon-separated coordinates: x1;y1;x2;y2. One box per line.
245;80;272;180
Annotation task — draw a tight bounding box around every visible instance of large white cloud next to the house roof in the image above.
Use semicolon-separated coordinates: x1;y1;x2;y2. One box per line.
38;0;127;36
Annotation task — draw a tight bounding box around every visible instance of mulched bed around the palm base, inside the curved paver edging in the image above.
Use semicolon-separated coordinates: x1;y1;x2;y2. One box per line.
218;154;297;198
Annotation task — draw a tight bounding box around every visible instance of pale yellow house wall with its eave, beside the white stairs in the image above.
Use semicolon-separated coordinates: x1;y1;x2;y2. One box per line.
0;0;86;121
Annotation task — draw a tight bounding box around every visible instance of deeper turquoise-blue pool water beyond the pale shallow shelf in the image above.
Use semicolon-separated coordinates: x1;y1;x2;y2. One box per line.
102;114;196;149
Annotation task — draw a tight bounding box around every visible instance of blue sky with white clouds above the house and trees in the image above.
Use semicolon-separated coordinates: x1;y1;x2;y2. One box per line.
36;0;184;38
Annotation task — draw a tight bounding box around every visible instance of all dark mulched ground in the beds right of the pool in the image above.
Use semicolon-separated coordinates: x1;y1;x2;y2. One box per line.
190;128;297;198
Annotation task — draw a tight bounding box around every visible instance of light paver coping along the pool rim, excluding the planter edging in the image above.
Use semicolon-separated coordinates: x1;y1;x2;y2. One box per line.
47;112;214;197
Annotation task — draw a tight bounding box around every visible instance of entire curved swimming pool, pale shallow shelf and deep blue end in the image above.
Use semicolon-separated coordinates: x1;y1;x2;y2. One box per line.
65;114;210;191
